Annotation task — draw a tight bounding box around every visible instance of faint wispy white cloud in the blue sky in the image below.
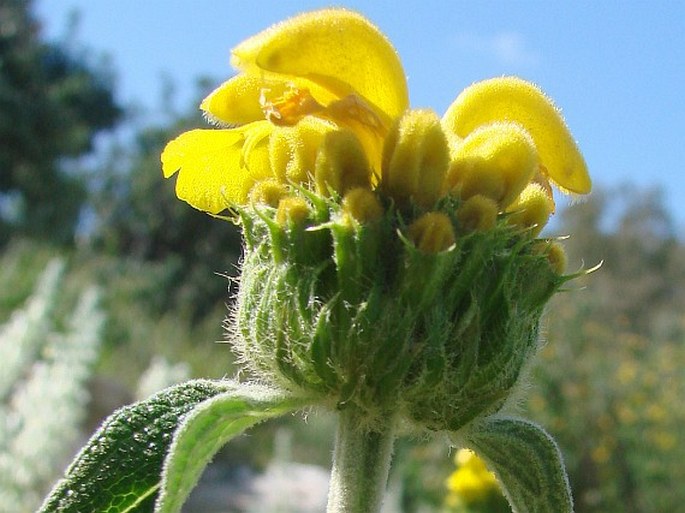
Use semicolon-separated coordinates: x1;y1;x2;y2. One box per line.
455;32;541;68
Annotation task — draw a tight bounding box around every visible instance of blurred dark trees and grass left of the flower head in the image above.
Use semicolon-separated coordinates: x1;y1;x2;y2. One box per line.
0;0;240;421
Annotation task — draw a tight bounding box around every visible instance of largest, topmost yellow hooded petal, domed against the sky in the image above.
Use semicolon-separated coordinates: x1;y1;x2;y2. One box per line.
232;9;409;122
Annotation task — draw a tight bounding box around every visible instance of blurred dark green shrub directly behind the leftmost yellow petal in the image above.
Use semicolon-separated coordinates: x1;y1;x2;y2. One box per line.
89;81;241;320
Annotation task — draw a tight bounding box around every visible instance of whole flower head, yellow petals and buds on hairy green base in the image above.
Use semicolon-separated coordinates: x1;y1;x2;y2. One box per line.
162;9;590;431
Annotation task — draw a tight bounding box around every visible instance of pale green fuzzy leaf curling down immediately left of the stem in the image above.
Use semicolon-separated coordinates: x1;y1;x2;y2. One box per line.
155;384;311;513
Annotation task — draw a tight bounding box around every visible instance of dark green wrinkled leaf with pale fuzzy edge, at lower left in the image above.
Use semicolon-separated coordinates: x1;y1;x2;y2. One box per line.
39;380;236;513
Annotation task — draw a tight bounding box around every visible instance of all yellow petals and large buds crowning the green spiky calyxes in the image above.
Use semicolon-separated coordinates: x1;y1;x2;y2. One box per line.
162;9;591;220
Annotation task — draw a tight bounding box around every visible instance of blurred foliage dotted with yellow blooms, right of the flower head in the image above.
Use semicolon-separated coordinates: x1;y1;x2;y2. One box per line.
529;187;685;513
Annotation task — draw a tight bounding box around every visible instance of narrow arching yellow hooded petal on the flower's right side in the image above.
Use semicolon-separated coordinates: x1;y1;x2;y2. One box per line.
443;77;592;194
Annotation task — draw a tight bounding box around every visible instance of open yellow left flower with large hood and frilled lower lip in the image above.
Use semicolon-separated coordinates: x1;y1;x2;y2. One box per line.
162;9;408;214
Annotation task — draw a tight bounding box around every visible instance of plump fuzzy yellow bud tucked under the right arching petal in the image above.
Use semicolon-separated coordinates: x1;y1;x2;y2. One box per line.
445;123;539;207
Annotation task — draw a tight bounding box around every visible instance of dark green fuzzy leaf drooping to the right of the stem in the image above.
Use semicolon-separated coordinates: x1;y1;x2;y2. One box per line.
465;417;573;513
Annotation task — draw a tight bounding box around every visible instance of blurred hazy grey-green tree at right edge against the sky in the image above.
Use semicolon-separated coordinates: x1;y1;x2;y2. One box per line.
561;185;685;336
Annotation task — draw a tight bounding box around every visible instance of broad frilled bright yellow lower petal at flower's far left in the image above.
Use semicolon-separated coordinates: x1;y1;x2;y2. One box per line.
162;122;271;214
